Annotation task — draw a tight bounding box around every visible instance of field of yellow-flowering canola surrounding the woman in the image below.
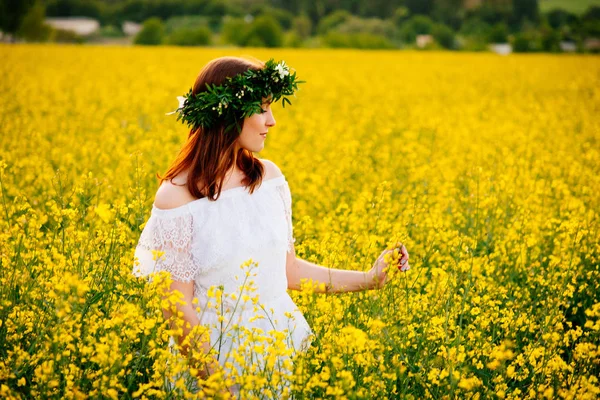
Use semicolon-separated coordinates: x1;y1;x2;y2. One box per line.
0;45;600;399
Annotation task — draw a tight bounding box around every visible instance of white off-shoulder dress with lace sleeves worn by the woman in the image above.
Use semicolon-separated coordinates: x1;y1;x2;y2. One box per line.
133;175;312;394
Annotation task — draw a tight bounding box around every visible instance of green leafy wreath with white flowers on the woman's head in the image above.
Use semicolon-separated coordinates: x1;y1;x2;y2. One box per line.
166;58;305;132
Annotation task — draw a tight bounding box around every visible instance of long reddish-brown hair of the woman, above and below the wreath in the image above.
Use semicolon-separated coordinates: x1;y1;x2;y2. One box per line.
156;56;264;201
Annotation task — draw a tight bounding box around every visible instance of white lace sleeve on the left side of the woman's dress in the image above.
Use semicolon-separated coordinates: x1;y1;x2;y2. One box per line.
133;208;200;282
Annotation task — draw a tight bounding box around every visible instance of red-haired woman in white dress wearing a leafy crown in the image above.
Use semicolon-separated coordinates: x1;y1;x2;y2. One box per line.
134;57;410;393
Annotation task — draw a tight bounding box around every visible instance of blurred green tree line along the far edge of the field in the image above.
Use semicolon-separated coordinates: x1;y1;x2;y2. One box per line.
0;0;600;51
